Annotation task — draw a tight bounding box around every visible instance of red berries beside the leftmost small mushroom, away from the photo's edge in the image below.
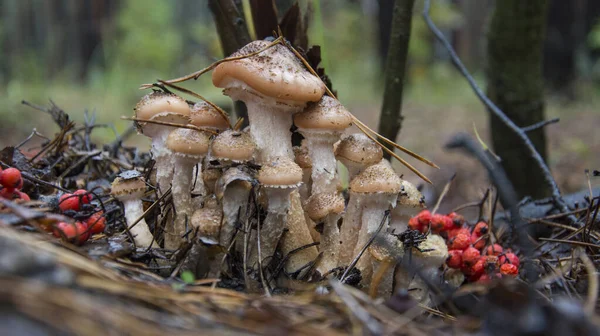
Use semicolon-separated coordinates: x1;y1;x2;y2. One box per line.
52;189;106;245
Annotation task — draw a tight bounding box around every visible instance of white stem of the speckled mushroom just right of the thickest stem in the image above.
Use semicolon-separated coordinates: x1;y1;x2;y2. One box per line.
302;130;339;195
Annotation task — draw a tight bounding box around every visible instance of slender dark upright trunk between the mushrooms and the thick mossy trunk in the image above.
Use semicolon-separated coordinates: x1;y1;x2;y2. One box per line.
378;0;415;159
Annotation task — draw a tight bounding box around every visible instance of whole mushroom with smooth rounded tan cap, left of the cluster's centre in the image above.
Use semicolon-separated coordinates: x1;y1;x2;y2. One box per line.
165;128;210;249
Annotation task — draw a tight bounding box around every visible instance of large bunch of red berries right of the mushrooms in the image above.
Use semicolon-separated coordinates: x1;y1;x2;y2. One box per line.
408;210;519;282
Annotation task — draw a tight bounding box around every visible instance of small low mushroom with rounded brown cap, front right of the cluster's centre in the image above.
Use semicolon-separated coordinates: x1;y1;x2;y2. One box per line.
304;192;346;275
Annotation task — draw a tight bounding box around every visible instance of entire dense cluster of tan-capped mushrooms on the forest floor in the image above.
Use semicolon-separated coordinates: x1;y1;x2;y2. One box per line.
115;41;447;298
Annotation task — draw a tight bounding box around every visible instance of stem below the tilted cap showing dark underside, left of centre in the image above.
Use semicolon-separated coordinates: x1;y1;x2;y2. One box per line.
219;182;250;248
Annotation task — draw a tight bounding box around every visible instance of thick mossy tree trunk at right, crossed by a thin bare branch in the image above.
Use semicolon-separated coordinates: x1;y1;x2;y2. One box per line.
487;0;551;199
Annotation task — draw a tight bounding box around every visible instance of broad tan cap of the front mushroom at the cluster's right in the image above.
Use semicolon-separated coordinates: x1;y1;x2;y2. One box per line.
350;160;402;194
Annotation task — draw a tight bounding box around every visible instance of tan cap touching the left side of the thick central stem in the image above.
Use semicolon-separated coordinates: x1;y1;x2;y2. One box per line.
211;130;256;162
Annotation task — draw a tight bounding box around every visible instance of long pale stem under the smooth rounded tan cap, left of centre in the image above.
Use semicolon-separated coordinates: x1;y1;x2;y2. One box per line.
165;156;197;249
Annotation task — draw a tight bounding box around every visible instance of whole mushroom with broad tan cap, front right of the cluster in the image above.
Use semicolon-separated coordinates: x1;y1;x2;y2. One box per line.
350;160;402;283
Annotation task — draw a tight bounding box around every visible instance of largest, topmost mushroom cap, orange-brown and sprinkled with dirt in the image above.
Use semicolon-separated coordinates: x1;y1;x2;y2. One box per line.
212;40;325;102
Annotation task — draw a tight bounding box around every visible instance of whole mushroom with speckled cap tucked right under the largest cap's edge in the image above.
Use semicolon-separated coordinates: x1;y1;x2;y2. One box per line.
294;96;352;194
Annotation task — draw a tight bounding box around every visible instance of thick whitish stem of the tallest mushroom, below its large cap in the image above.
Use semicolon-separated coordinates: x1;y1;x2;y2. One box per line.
225;87;304;162
